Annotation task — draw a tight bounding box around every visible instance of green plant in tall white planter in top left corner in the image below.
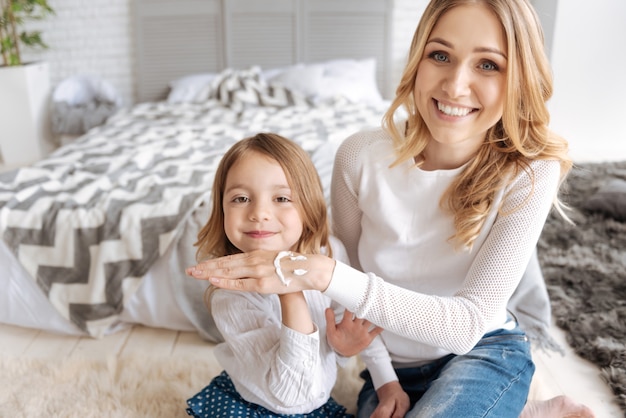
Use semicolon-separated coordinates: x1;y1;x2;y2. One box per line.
0;0;54;168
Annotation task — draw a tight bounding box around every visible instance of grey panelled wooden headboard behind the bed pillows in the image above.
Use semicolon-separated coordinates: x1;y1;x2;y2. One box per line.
133;0;392;102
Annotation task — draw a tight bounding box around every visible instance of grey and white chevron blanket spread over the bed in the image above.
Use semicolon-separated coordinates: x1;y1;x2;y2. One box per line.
0;90;385;337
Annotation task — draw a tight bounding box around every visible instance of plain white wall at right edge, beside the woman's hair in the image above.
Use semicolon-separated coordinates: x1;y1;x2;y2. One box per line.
549;0;626;161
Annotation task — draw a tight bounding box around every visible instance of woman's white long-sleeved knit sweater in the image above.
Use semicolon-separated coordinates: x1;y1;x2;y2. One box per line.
325;124;560;388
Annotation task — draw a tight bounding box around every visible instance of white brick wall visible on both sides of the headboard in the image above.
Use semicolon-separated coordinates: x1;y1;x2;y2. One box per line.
24;0;427;104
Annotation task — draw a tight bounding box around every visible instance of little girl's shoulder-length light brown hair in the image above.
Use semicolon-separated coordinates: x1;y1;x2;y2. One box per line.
194;133;332;309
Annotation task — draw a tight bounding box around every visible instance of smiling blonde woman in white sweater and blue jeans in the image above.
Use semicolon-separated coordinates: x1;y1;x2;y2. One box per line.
188;0;593;418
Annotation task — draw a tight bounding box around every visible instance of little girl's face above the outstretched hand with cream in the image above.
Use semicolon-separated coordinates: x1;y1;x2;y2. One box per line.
222;152;302;252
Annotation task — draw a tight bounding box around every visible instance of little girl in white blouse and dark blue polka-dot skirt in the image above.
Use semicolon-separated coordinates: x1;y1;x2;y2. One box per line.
187;133;376;418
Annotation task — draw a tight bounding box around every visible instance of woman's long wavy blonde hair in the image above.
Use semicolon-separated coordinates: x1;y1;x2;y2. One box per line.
383;0;572;248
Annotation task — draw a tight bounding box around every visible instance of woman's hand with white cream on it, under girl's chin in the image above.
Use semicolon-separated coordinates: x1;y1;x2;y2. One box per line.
185;250;335;294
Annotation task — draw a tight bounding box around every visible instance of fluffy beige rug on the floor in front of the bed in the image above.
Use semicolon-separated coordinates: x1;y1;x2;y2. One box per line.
0;356;361;418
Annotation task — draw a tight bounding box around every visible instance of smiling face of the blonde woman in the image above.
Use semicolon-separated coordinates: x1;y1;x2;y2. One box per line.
413;4;507;165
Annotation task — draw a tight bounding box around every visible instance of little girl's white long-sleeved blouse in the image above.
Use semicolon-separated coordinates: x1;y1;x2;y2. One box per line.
211;237;354;414
